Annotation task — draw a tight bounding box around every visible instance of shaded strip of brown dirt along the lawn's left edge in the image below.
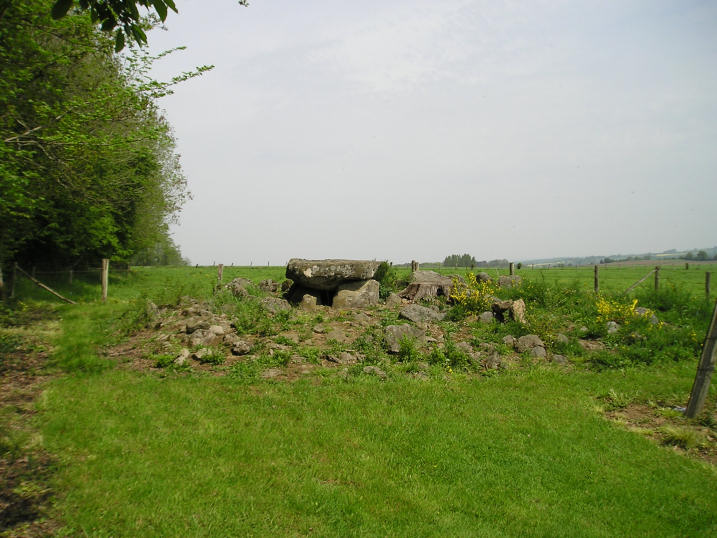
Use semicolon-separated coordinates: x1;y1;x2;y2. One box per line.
0;315;58;536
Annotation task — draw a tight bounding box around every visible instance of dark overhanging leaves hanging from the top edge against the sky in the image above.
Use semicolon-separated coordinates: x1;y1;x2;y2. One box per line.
46;0;249;52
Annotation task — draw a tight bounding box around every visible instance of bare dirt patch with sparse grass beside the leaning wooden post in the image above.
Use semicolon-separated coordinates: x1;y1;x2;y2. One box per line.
606;402;717;465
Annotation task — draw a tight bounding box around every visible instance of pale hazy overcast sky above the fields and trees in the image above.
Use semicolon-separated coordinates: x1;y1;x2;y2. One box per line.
149;0;717;265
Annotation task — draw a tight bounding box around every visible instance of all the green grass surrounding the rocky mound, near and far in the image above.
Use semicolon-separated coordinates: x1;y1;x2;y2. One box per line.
0;266;717;536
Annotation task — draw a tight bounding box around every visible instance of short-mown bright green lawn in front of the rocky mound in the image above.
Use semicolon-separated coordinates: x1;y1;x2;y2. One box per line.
40;364;717;536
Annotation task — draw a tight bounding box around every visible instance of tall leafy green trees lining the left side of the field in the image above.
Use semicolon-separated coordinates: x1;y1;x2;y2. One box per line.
0;0;203;274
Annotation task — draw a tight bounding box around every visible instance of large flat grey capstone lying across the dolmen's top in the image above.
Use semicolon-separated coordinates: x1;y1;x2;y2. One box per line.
286;258;380;290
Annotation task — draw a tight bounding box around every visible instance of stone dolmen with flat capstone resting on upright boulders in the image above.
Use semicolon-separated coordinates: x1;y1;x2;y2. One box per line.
286;258;381;308
